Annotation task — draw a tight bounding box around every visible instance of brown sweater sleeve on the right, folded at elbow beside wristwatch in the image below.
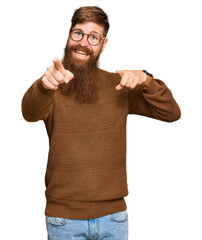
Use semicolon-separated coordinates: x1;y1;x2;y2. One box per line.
128;79;181;122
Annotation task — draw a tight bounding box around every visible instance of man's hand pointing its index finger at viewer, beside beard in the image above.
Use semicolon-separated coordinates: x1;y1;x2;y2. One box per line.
42;58;74;90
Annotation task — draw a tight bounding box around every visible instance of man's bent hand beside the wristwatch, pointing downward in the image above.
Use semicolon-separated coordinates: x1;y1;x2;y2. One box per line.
116;70;147;90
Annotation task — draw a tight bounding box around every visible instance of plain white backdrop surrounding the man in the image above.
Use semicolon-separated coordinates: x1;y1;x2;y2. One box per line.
0;0;202;240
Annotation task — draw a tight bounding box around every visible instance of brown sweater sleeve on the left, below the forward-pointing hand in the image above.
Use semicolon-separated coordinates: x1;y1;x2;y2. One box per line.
21;78;55;122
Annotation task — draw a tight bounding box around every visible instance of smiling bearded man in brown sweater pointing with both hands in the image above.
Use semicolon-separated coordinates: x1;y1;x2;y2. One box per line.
22;7;180;240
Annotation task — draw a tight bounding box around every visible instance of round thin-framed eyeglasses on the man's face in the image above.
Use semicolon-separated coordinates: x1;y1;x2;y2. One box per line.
70;29;105;46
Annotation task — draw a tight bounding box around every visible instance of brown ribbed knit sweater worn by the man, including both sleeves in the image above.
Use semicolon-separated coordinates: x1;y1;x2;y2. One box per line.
22;70;180;219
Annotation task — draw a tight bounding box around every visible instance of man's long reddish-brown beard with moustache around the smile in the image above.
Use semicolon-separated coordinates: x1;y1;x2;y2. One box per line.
60;44;100;103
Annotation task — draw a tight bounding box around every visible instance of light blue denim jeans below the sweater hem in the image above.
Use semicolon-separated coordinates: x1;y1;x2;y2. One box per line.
46;210;128;240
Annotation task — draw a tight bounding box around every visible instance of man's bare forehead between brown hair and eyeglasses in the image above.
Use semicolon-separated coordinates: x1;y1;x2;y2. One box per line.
73;22;104;35
